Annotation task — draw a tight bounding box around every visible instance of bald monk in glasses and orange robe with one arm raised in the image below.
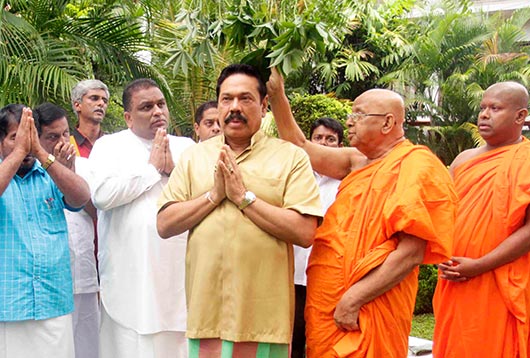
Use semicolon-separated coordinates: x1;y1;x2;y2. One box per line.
267;70;457;358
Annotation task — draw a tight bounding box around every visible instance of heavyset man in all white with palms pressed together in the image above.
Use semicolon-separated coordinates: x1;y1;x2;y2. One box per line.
90;78;194;358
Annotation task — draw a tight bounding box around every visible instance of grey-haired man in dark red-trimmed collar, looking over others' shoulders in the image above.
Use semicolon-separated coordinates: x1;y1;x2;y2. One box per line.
70;80;109;158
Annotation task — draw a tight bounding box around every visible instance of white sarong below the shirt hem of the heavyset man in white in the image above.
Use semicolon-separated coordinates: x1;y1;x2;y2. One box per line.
99;305;188;358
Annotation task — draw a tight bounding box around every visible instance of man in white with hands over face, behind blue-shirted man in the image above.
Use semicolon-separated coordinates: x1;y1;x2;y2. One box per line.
33;103;100;358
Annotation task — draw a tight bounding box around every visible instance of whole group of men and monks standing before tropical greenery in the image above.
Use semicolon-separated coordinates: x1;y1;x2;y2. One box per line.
0;64;530;358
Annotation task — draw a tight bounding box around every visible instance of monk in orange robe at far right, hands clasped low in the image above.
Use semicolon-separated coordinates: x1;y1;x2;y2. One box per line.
434;82;530;358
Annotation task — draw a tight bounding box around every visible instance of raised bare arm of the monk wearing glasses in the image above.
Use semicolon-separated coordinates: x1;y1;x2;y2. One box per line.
267;68;356;179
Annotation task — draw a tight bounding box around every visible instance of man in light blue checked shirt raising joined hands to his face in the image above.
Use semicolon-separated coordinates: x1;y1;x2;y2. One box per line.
0;105;90;358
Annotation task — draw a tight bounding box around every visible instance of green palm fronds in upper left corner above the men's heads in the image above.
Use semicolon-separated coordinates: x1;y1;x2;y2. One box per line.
0;0;162;127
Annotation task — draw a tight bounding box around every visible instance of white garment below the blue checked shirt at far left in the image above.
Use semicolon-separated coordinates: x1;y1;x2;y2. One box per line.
0;314;74;358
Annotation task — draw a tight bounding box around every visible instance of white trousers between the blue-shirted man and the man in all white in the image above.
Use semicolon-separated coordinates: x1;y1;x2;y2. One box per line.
72;292;100;358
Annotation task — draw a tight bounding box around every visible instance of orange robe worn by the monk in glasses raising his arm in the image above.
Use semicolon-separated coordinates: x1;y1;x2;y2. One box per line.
305;141;457;358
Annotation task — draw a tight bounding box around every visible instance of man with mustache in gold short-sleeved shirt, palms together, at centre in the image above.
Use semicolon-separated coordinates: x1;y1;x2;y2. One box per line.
157;64;321;358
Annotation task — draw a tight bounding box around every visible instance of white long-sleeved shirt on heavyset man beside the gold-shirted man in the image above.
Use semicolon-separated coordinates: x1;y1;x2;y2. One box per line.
90;130;194;334
